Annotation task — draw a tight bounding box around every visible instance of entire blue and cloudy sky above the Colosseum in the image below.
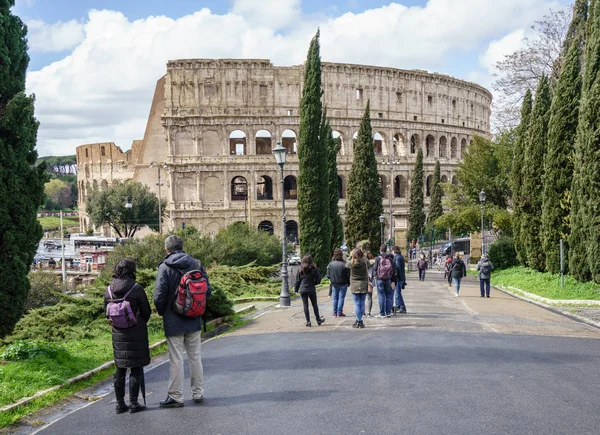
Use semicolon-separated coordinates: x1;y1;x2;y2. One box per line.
13;0;570;156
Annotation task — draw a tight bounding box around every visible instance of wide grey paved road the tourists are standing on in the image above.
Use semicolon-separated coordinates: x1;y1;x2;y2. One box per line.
17;273;600;435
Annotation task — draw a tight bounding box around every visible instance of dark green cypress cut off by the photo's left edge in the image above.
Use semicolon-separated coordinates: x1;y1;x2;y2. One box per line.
0;0;45;337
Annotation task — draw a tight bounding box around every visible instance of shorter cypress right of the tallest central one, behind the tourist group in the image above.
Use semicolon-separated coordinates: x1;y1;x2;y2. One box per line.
346;101;383;252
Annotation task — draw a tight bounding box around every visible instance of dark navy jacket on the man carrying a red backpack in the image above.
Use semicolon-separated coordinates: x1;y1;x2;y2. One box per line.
154;251;212;337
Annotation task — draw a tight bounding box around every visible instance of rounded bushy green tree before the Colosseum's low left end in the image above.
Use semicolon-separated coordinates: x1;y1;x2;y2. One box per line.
87;181;166;237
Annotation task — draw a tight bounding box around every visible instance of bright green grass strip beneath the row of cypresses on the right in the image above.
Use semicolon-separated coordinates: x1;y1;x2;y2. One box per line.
491;266;600;300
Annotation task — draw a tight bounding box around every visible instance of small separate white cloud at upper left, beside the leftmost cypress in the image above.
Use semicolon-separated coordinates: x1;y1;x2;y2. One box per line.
26;20;84;52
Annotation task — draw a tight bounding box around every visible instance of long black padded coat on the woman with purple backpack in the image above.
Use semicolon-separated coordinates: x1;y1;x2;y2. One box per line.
104;278;152;368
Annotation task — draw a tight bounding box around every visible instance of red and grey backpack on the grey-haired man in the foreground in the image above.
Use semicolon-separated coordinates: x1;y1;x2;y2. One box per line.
173;270;208;319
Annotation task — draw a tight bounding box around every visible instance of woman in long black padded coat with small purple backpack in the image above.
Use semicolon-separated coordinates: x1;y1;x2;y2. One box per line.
104;258;152;414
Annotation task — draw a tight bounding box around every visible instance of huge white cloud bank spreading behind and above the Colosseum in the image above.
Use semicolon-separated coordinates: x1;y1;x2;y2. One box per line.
27;0;555;154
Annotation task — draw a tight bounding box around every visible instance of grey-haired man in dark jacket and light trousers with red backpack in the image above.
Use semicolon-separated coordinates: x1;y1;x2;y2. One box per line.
154;235;212;408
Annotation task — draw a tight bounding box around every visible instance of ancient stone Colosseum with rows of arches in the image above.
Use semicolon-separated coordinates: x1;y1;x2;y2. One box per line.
77;59;492;246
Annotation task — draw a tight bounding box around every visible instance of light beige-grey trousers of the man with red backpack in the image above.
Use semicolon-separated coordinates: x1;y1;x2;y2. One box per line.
167;331;204;402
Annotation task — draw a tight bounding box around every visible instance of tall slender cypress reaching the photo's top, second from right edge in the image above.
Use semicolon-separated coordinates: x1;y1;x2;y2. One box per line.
542;0;587;273
